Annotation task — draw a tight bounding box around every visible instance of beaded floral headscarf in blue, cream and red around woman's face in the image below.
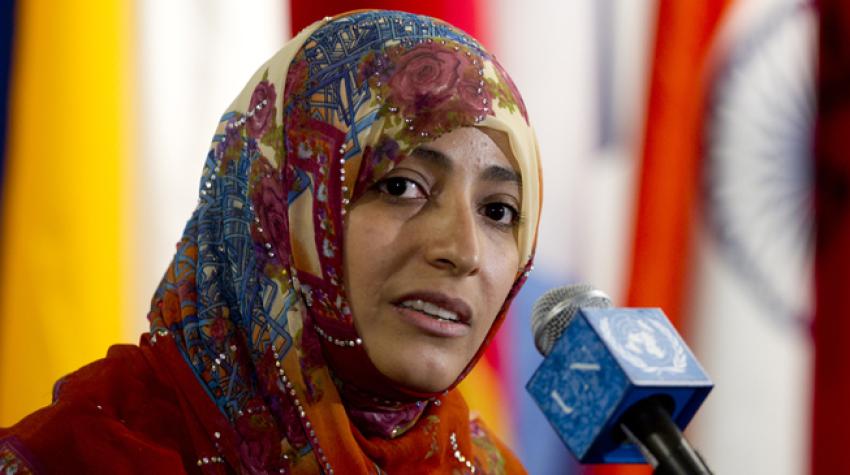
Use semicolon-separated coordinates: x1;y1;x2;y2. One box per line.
149;11;540;473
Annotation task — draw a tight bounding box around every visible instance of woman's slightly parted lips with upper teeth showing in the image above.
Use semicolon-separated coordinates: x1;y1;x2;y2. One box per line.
393;292;472;338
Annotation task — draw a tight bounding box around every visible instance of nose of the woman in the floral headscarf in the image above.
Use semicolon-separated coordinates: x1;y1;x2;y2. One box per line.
423;197;481;275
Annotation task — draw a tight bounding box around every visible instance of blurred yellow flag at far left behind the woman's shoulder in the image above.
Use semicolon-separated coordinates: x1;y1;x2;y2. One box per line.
0;0;132;426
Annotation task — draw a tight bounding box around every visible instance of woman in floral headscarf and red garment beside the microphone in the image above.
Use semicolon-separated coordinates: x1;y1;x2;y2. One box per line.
0;11;540;474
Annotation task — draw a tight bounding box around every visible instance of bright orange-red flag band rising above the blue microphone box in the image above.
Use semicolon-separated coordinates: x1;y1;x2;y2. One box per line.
627;0;731;326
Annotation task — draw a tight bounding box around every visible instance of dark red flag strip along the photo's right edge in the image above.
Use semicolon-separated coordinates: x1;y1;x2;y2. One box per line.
811;0;850;474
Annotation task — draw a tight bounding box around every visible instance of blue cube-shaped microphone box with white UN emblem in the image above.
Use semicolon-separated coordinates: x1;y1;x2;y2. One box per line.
526;308;713;463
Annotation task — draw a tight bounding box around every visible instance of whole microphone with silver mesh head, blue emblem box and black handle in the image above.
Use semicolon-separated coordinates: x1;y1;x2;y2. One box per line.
526;284;714;475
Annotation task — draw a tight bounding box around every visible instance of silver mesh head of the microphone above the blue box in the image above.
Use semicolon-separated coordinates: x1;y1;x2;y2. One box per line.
531;284;611;356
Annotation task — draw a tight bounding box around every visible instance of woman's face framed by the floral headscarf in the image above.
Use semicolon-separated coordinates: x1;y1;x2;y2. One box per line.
345;127;521;392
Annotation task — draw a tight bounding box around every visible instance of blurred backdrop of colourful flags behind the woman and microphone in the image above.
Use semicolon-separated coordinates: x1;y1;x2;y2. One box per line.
0;0;850;475
